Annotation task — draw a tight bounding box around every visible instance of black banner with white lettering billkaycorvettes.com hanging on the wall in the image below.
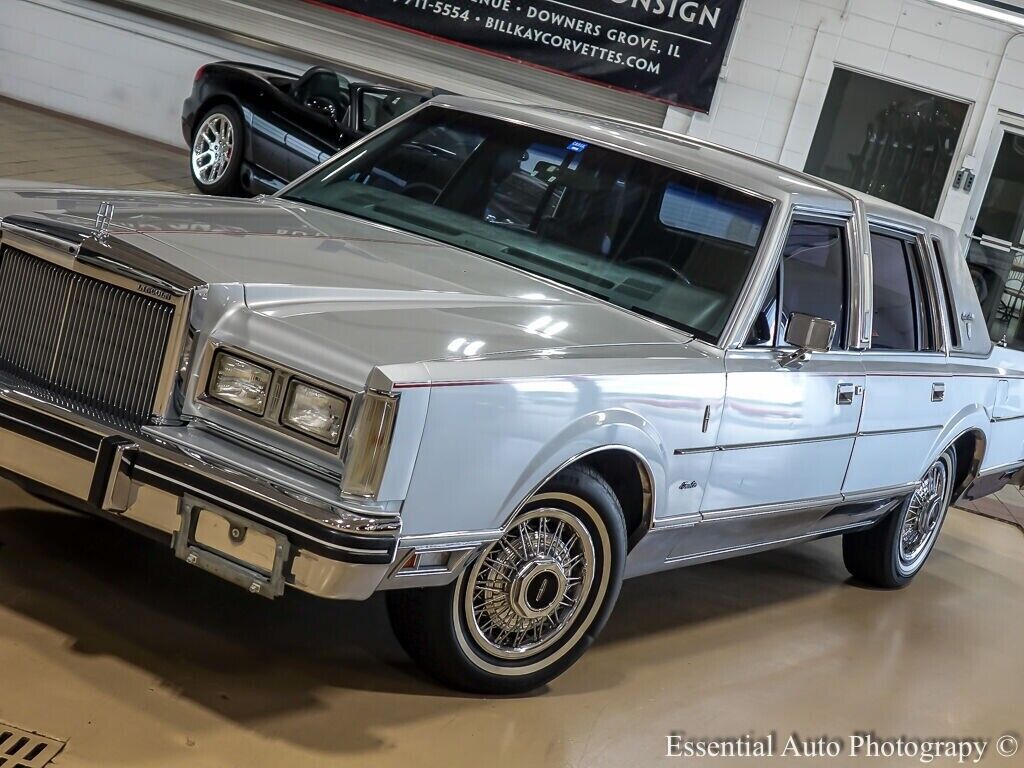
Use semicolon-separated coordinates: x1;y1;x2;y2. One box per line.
318;0;742;112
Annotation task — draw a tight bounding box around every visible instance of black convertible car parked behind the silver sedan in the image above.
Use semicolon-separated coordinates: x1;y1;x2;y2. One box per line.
181;61;433;195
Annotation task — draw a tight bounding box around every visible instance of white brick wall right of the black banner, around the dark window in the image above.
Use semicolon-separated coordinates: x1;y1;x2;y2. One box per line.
679;0;1024;234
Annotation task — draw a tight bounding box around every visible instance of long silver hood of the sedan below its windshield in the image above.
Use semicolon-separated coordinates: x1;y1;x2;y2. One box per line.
0;188;688;370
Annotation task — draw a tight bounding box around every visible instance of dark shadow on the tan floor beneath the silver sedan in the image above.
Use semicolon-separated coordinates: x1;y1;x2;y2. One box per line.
0;509;905;752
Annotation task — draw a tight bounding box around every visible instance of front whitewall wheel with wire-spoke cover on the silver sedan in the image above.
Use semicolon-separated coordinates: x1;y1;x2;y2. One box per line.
388;466;626;694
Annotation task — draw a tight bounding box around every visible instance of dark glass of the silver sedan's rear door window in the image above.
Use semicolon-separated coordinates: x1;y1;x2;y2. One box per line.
871;232;934;351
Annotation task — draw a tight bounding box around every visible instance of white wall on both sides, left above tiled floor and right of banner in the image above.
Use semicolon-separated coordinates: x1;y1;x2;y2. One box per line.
0;0;1024;237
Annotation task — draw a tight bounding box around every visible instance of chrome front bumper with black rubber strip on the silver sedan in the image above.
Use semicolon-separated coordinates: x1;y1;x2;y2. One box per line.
0;380;401;599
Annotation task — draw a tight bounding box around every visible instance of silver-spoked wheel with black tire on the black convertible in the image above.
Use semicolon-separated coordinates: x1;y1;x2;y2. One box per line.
188;104;246;197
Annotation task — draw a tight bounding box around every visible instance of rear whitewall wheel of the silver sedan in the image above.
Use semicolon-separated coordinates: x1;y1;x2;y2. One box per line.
843;446;956;589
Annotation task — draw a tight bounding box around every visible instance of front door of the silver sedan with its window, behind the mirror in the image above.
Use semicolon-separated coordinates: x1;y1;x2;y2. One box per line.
700;219;864;539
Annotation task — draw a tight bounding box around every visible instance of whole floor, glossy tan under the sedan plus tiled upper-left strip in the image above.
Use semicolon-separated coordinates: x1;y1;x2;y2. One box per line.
0;101;1024;768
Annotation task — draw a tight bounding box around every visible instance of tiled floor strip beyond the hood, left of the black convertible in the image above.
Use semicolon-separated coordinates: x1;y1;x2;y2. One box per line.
0;98;196;191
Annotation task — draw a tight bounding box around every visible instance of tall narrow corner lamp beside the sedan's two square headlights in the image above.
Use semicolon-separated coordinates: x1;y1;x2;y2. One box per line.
341;391;398;498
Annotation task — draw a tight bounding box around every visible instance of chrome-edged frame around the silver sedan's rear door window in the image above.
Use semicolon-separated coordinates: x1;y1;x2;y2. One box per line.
863;222;949;355
